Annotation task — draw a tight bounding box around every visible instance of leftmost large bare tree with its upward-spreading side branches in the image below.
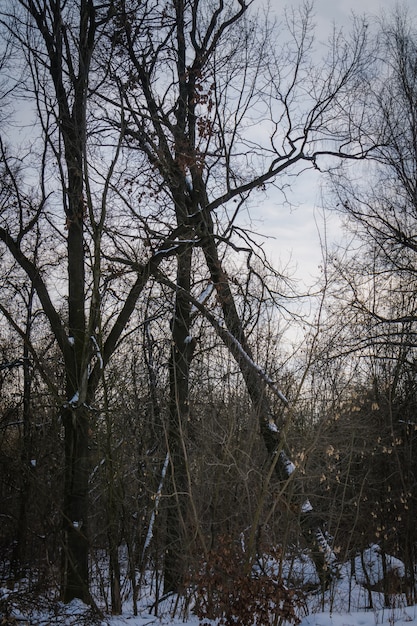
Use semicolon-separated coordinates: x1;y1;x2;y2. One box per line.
0;0;184;601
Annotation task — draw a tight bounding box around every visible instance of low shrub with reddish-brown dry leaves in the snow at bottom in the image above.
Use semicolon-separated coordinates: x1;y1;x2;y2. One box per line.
192;537;300;626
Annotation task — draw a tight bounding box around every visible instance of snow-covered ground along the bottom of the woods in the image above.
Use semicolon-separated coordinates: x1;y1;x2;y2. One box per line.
0;545;417;626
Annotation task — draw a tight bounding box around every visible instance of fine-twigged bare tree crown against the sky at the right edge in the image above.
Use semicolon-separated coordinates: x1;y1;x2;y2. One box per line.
333;9;417;333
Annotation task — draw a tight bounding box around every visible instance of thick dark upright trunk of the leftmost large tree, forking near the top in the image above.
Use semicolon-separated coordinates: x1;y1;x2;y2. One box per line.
18;0;97;602
